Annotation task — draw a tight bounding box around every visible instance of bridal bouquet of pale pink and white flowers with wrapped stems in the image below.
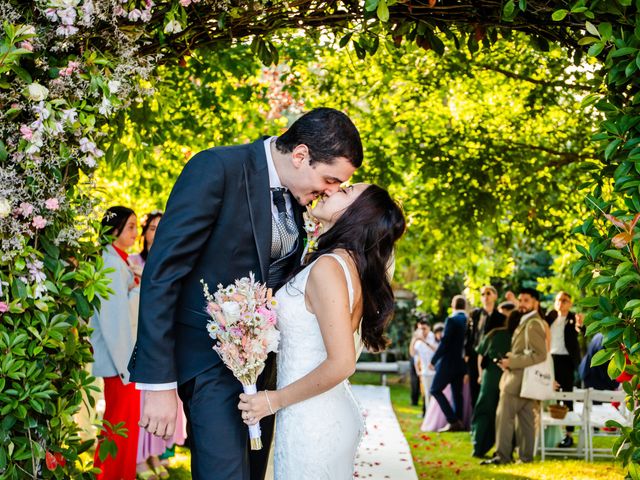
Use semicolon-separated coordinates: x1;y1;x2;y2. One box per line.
201;272;280;450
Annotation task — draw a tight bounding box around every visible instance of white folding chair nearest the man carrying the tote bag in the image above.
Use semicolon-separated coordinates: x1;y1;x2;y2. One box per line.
538;389;589;461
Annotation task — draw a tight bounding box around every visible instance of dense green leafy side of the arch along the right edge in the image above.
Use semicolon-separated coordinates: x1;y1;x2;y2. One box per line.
554;1;640;472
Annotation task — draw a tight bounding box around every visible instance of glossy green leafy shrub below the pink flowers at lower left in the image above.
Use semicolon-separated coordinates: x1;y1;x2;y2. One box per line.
0;229;109;479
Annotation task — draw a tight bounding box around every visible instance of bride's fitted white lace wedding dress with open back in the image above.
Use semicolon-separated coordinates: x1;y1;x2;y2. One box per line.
274;254;364;480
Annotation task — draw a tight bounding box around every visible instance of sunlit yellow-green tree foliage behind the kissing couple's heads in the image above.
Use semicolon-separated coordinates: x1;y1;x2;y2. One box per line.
98;36;595;311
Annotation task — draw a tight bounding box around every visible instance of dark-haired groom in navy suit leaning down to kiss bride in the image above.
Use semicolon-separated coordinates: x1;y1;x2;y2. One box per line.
129;108;363;480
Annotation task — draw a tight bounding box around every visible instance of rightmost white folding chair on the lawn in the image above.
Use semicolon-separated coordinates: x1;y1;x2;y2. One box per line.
587;388;633;461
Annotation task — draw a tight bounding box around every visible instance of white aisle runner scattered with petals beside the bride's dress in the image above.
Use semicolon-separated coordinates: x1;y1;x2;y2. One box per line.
352;385;418;480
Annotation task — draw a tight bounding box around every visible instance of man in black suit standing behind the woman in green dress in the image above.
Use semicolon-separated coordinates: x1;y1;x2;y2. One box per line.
464;285;505;405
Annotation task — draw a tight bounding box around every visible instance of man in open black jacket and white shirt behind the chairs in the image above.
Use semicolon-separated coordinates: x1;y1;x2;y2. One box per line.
545;292;580;448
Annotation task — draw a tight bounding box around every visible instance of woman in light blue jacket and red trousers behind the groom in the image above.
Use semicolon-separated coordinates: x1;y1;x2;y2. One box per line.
89;206;140;480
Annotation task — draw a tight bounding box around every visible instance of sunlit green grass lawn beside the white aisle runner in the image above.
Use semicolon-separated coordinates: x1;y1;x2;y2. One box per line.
152;373;624;480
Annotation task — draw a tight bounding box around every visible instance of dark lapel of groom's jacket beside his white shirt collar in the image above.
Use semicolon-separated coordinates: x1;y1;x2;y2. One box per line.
244;137;271;281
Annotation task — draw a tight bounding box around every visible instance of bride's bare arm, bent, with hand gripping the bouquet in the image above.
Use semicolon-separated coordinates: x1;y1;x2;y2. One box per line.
238;257;359;424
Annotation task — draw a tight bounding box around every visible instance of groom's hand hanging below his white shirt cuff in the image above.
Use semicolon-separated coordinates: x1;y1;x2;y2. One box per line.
138;388;178;440
